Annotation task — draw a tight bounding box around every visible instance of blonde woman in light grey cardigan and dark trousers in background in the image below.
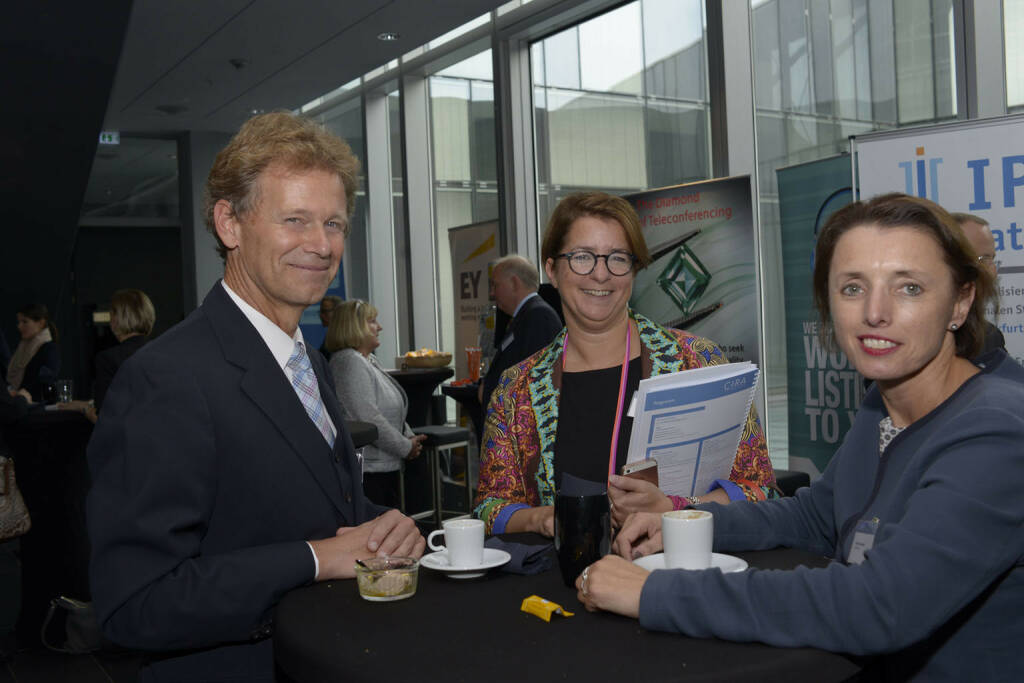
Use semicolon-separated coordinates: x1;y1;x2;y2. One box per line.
325;299;426;507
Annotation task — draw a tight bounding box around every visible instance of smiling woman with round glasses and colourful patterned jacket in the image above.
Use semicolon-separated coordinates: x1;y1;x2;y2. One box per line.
475;193;777;537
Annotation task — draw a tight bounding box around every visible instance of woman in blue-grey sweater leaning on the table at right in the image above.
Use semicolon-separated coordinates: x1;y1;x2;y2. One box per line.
577;195;1024;681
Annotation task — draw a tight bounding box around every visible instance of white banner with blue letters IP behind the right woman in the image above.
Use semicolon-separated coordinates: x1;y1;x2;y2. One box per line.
853;116;1024;362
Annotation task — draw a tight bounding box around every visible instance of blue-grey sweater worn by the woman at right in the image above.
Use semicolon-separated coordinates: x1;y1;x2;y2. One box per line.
640;351;1024;681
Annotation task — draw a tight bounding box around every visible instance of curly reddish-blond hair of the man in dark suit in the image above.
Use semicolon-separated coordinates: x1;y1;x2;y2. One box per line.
203;112;359;258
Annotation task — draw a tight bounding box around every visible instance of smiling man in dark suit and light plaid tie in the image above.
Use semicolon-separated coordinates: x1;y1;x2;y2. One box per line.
88;113;424;683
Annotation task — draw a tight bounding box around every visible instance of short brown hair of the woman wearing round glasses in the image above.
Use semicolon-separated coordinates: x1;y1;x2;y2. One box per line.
541;193;650;270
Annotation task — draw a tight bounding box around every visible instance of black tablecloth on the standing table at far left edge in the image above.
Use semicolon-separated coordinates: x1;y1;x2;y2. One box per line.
4;411;92;641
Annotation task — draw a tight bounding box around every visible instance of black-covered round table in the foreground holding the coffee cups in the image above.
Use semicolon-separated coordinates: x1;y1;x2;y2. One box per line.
273;550;859;683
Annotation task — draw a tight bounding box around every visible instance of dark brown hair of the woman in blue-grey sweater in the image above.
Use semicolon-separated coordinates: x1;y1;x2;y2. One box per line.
814;193;995;358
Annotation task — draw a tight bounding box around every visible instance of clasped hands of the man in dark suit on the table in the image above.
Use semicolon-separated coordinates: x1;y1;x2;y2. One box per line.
309;510;426;581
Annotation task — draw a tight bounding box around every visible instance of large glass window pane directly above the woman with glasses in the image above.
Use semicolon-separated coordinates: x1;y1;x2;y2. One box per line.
530;0;711;225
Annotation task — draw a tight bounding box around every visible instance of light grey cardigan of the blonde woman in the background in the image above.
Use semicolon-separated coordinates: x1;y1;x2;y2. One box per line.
331;348;413;472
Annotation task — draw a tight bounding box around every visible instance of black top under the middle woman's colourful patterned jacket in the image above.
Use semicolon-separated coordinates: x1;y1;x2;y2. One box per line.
555;356;640;487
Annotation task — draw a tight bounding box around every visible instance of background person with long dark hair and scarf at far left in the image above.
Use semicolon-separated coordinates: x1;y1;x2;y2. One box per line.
7;303;60;400
